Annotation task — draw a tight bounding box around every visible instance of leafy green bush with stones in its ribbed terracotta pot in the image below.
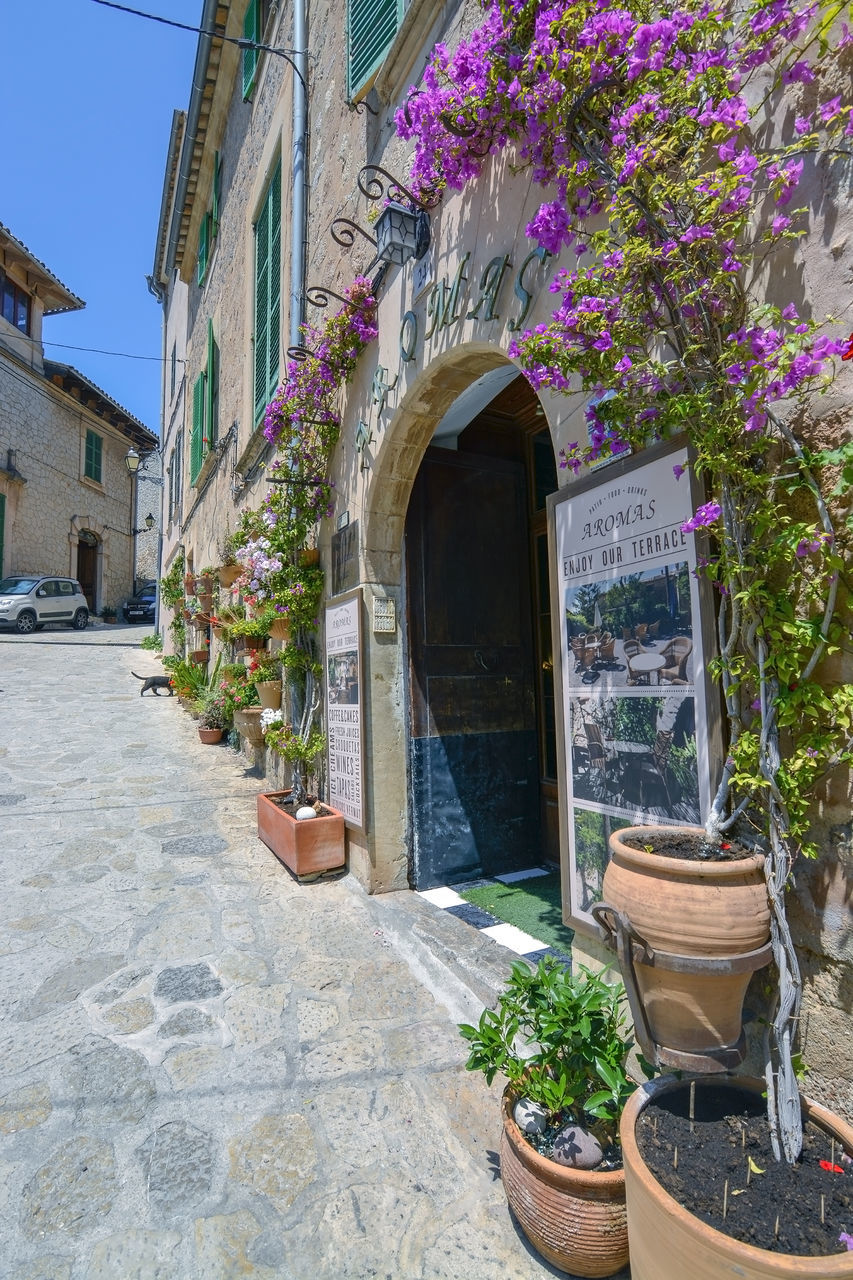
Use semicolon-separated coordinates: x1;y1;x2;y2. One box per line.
460;956;637;1276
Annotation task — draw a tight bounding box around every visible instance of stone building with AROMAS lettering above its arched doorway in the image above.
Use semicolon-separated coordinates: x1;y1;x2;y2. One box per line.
155;0;853;1111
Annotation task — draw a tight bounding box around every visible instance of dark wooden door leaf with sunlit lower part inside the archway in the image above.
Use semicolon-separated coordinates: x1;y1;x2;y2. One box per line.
406;448;539;888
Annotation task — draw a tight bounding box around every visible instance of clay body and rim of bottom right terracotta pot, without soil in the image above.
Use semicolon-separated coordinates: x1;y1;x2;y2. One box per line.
621;1075;853;1280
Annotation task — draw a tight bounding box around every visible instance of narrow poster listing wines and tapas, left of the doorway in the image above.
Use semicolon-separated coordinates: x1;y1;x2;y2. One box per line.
325;591;365;831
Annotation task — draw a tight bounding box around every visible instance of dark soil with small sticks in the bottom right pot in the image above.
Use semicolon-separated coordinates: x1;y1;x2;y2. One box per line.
635;1083;853;1257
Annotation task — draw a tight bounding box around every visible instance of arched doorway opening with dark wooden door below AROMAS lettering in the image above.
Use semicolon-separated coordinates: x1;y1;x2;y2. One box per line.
405;370;558;888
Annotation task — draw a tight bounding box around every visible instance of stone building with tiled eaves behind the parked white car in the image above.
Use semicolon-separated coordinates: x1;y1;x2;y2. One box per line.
0;227;159;613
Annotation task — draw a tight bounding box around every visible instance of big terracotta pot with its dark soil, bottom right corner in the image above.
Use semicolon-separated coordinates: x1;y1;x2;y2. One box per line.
621;1075;853;1280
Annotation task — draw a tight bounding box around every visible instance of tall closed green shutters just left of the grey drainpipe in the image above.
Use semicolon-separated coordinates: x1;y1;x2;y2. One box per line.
254;163;282;422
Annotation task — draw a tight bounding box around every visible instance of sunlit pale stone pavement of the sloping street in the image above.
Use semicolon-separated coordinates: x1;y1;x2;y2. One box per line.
0;626;627;1280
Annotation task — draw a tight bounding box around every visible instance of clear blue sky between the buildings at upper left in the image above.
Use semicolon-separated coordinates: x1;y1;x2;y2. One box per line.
0;0;202;434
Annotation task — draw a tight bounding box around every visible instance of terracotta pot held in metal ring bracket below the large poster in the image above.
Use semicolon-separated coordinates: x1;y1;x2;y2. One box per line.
594;827;770;1071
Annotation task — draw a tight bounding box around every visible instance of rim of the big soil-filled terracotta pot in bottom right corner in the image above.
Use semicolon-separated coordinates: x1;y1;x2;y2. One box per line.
620;1075;853;1280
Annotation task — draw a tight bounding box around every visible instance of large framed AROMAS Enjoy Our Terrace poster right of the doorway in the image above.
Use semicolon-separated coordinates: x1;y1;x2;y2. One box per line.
551;447;712;929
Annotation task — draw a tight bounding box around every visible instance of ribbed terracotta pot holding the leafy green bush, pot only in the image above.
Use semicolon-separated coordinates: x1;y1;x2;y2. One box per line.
501;1089;625;1280
